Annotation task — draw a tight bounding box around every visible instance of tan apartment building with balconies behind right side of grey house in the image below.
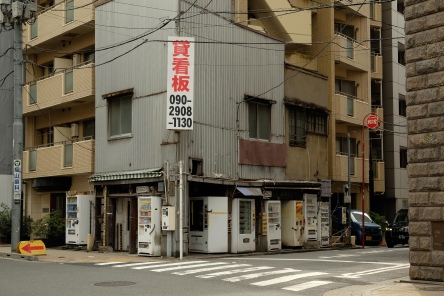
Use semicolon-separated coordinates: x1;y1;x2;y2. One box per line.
236;0;385;211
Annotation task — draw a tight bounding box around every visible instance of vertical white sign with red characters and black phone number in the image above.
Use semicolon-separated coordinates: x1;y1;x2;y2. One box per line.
166;36;194;130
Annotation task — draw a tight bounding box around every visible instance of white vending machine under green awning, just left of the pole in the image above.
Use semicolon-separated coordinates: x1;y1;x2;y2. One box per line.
137;196;162;256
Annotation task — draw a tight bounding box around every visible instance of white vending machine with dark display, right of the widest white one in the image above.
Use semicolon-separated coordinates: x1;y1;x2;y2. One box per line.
231;198;256;253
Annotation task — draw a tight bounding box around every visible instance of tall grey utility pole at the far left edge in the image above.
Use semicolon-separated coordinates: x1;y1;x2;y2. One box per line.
0;0;37;252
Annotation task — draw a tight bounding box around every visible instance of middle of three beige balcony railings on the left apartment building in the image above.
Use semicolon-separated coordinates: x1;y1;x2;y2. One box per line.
23;64;95;114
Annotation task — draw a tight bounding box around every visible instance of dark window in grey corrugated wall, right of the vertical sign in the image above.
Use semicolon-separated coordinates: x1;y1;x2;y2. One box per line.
248;101;271;140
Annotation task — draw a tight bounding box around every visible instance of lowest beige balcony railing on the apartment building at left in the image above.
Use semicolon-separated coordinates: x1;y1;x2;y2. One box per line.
23;138;95;179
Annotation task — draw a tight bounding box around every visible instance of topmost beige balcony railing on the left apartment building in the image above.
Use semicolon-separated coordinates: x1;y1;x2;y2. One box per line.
25;0;94;46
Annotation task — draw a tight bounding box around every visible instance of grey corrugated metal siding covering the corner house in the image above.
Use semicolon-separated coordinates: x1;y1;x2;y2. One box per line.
96;1;285;179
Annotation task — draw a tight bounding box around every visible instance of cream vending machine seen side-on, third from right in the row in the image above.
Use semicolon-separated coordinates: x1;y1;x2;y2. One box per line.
282;200;304;247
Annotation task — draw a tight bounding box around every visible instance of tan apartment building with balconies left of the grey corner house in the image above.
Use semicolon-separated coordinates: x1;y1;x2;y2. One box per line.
22;0;95;219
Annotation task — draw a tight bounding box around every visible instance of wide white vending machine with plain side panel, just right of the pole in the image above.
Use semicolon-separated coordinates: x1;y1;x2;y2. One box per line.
189;196;228;253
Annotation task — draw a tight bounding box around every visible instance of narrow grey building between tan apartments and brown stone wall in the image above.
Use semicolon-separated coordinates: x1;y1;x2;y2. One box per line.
382;0;408;219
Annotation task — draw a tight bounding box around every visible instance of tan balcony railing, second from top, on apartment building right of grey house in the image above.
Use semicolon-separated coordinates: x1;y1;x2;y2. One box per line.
334;33;370;71
